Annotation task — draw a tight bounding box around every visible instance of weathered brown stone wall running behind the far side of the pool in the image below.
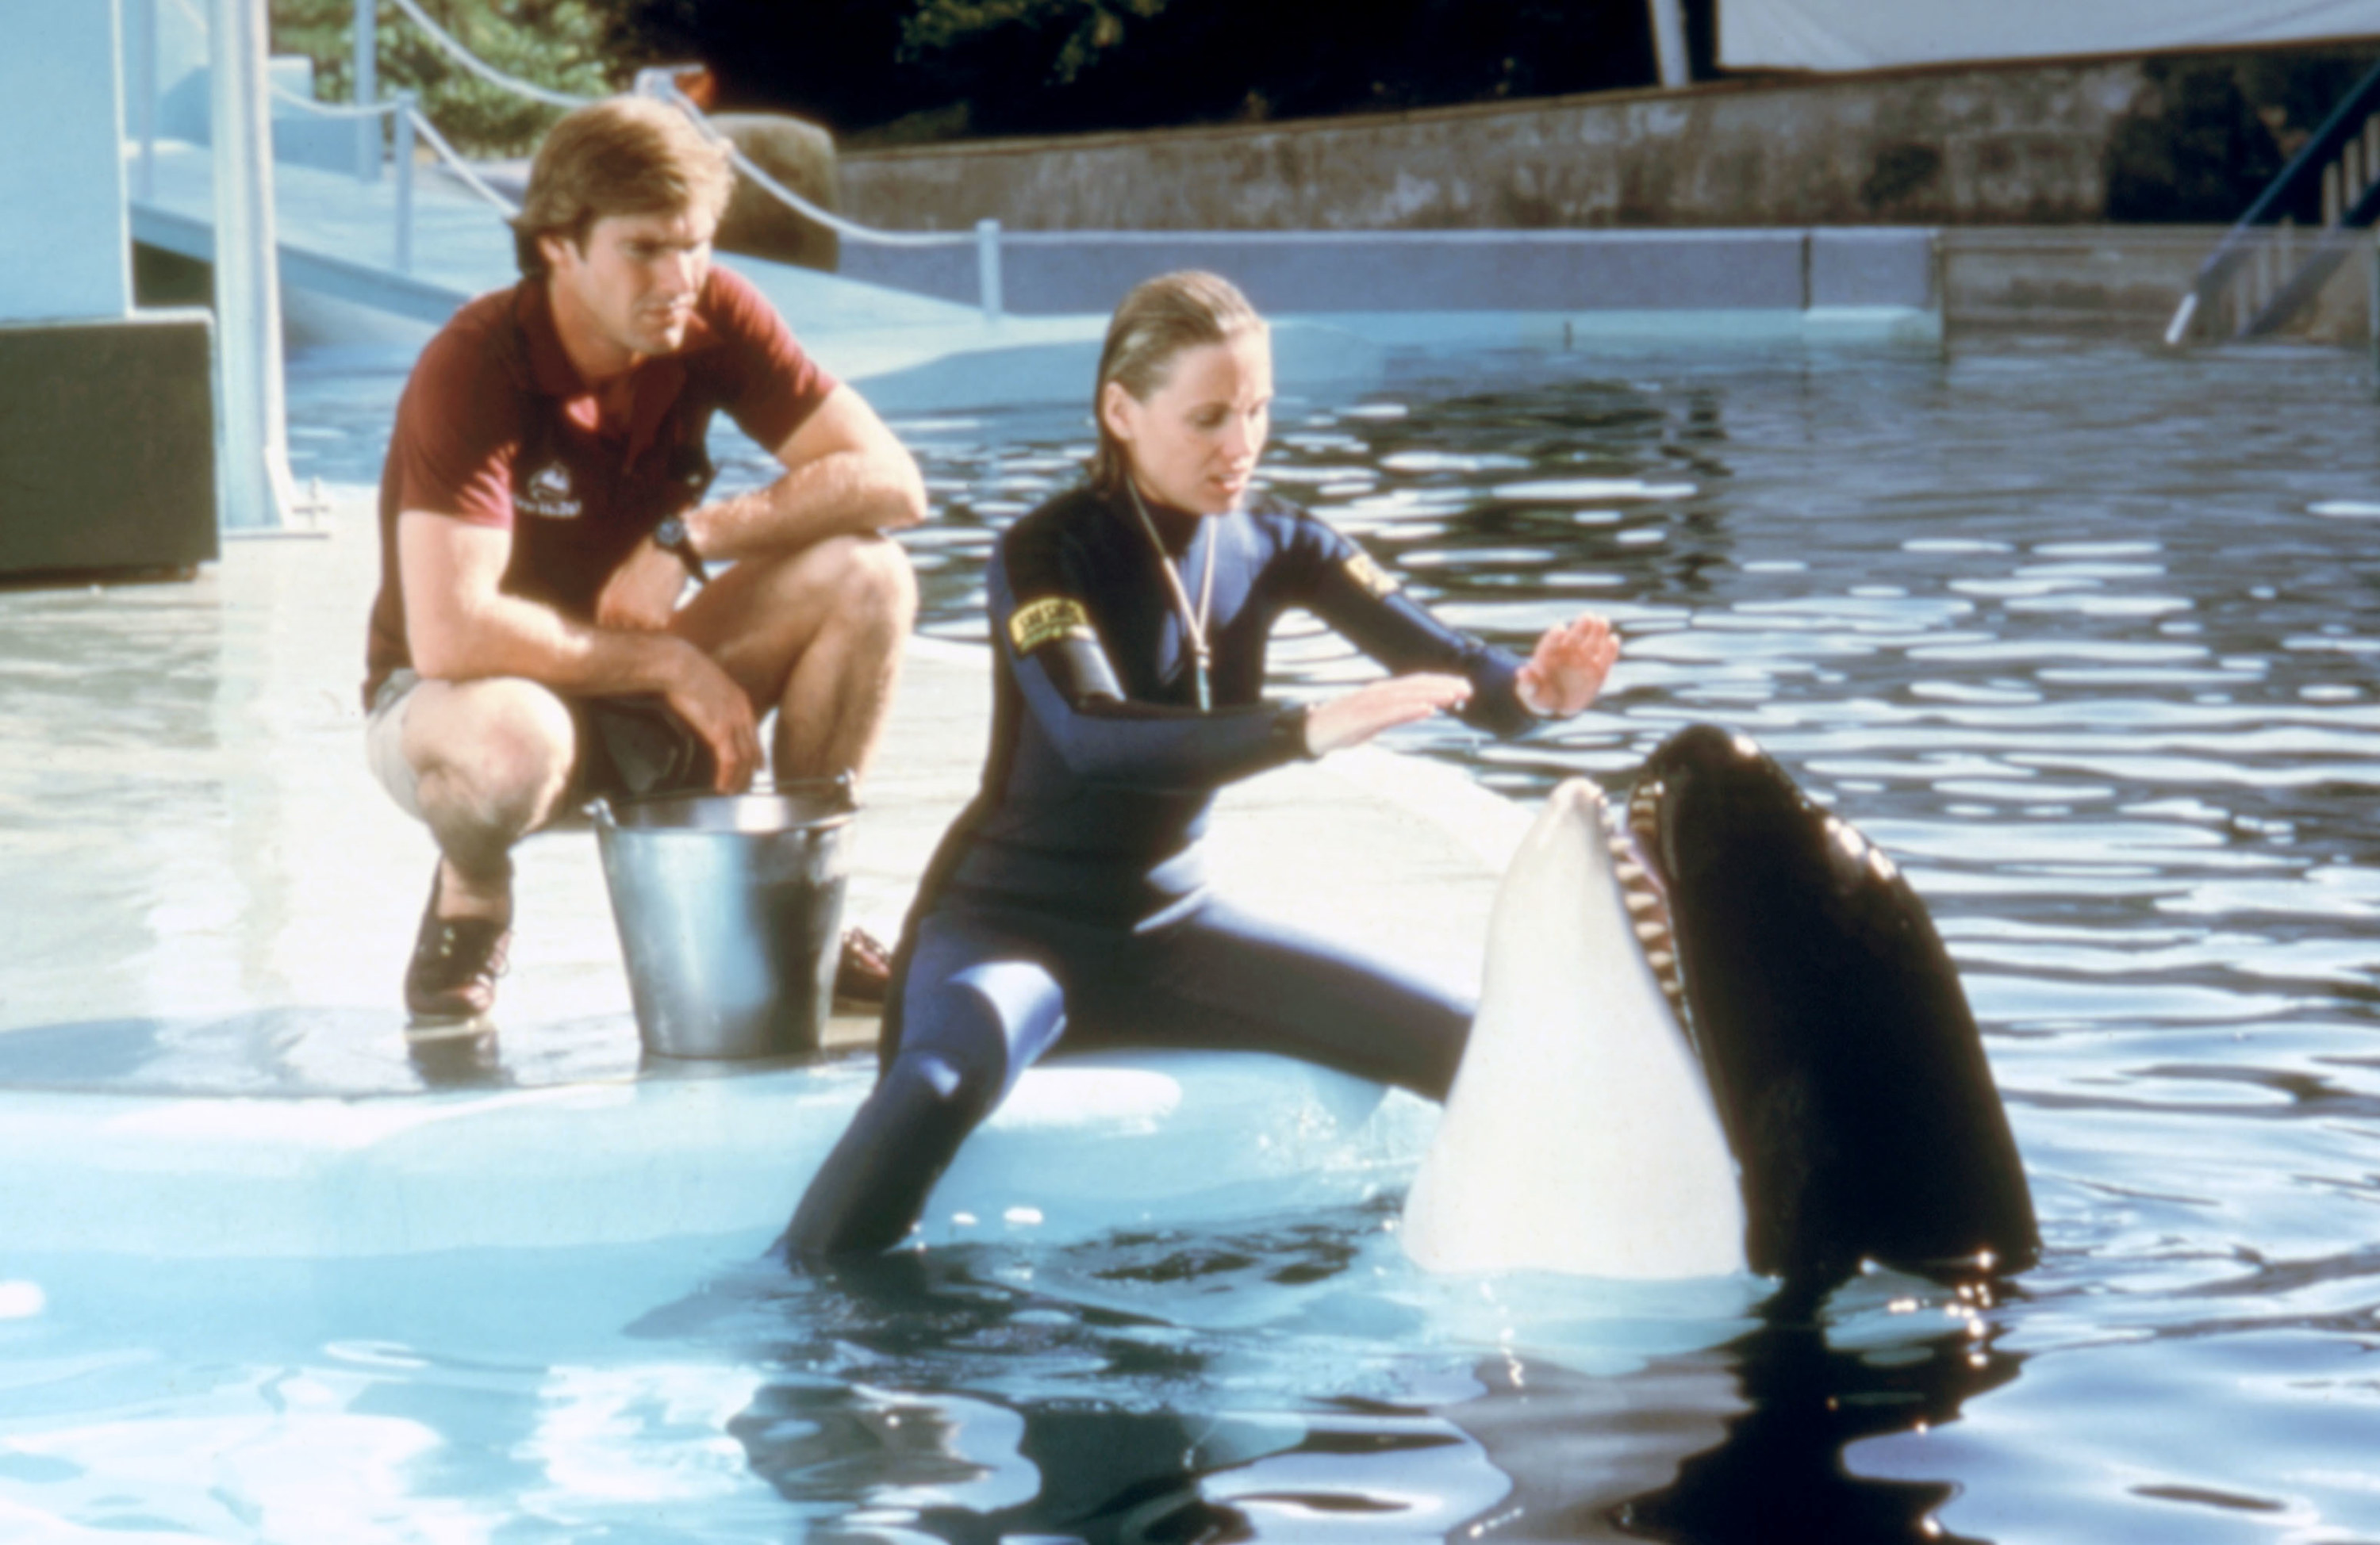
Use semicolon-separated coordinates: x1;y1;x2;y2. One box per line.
840;59;2144;231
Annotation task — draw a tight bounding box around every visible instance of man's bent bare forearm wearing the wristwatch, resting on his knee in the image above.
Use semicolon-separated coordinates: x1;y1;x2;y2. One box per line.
685;385;926;559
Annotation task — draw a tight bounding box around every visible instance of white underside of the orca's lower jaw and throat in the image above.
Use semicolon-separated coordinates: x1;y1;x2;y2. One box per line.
1399;779;1745;1279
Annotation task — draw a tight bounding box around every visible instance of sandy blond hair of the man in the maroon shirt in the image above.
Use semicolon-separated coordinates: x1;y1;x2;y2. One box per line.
512;98;735;278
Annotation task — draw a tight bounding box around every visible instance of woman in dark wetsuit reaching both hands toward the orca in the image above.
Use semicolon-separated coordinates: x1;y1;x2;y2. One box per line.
785;274;1618;1259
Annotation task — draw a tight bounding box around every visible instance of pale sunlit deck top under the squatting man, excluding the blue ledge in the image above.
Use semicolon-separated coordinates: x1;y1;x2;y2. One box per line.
0;488;1516;1098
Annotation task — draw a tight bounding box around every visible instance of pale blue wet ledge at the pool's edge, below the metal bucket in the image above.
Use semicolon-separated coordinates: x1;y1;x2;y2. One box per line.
0;1052;1435;1262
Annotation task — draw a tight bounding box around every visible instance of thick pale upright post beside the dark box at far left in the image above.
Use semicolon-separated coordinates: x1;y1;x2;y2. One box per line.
207;0;288;531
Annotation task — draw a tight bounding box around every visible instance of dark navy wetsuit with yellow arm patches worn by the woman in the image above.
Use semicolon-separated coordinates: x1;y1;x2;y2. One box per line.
785;488;1535;1257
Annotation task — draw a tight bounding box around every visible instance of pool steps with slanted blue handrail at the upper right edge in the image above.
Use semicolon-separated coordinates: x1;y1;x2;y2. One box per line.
2166;67;2380;347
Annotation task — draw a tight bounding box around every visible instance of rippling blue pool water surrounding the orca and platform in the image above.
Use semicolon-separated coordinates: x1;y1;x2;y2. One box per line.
0;340;2380;1543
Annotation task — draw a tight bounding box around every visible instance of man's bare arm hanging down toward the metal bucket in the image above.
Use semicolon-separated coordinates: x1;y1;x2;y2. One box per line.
397;509;759;793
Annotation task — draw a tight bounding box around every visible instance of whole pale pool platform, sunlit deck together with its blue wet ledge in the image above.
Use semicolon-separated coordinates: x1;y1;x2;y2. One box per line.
0;488;1526;1259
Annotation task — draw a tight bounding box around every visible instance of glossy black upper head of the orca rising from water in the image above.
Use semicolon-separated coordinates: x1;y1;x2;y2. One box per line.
1628;726;2040;1281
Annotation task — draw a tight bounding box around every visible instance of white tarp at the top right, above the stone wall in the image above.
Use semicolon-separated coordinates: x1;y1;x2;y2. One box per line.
1718;0;2380;69
